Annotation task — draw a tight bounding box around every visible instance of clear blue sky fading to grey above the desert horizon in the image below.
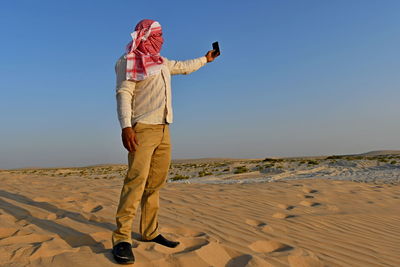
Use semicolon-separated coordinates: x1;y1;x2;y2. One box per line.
0;0;400;168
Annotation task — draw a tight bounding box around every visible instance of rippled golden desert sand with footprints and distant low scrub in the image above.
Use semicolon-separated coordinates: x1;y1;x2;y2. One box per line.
0;152;400;267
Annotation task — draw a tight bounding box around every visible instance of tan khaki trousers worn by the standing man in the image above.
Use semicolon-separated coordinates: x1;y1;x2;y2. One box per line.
112;122;171;246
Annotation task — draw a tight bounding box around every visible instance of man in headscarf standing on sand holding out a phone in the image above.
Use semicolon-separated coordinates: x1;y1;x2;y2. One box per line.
112;19;219;263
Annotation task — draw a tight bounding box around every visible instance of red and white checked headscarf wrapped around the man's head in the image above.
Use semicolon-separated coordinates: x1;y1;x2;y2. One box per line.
125;19;164;81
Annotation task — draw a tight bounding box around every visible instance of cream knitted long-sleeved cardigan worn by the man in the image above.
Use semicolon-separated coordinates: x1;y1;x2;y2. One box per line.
115;55;207;129
